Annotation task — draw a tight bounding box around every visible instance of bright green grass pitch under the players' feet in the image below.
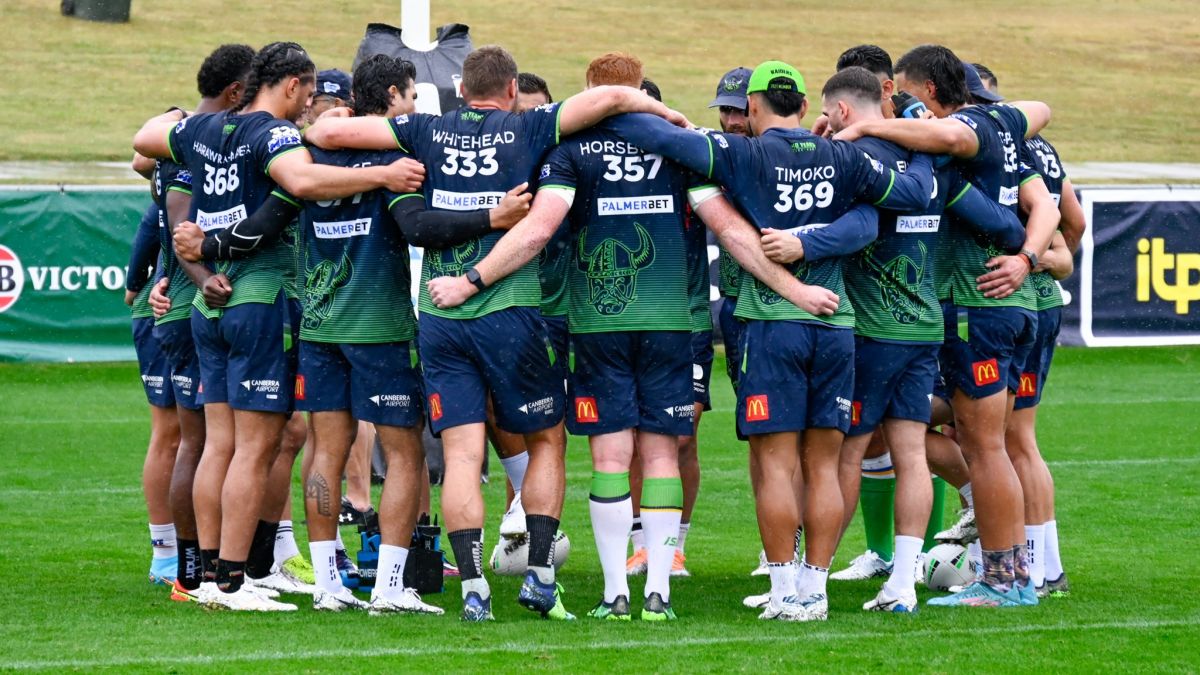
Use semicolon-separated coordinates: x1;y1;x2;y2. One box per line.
0;347;1200;673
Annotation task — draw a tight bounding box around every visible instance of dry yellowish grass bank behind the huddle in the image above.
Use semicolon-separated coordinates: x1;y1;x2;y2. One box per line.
0;0;1200;162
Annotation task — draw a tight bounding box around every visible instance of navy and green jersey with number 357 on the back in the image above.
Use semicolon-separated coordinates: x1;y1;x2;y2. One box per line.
539;129;716;333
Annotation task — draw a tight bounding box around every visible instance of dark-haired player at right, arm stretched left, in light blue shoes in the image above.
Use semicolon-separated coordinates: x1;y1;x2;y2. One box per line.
838;46;1058;607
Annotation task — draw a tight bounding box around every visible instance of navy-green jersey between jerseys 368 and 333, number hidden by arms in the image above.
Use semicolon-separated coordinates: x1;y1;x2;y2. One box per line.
300;148;425;344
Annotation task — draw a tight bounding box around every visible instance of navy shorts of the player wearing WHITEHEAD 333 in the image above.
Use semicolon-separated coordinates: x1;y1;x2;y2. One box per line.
418;307;564;434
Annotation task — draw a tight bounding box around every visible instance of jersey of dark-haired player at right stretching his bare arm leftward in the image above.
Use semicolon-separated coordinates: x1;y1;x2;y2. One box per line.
948;104;1037;310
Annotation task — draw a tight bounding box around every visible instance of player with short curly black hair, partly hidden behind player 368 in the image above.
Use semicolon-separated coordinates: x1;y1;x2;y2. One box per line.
141;44;256;602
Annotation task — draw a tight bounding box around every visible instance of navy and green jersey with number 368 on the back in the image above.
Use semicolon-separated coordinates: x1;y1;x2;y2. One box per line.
167;112;304;318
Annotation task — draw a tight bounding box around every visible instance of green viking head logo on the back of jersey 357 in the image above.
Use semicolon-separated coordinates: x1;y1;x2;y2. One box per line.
576;222;654;316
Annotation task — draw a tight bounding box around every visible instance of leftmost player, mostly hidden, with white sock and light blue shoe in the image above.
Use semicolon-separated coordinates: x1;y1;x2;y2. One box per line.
125;204;180;586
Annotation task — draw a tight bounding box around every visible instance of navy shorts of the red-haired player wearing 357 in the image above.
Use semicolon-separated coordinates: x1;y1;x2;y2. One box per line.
566;330;696;436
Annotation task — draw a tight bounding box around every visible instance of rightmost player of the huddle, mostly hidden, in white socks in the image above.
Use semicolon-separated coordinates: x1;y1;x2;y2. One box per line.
973;64;1087;597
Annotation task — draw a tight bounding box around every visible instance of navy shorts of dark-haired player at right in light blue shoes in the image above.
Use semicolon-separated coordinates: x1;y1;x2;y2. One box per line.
942;306;1038;399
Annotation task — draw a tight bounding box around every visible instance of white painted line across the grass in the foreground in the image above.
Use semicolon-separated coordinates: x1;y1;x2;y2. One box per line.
0;616;1200;670
